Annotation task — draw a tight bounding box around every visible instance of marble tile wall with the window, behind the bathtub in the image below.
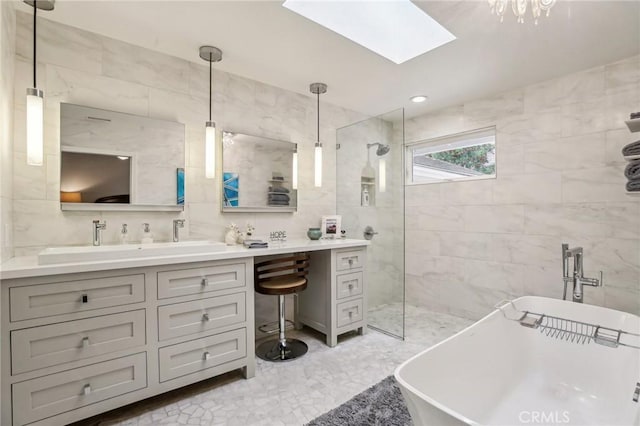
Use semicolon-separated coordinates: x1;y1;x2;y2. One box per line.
406;56;640;318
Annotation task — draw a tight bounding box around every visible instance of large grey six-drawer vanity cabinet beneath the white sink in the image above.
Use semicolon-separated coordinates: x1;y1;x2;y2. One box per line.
0;257;255;426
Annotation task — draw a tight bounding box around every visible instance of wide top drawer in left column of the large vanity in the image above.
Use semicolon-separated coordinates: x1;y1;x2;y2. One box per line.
9;274;144;321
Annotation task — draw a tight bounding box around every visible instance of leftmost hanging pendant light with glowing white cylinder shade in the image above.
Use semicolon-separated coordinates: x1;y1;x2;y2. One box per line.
25;0;55;166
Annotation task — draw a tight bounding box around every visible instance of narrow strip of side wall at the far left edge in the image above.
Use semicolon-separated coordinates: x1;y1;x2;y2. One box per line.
0;1;15;262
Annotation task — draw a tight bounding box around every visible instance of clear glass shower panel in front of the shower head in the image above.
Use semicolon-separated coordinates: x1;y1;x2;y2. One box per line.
336;109;405;338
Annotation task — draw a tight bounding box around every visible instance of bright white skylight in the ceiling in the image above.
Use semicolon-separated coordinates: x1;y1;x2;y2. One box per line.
283;0;456;64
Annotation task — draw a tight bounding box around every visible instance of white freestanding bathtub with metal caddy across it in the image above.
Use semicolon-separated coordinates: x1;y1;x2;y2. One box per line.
395;296;640;426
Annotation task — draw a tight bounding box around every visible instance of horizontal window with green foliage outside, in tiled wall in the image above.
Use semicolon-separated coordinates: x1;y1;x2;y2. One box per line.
406;127;496;184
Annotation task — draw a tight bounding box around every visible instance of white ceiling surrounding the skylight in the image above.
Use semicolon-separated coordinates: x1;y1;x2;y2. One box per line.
25;0;640;116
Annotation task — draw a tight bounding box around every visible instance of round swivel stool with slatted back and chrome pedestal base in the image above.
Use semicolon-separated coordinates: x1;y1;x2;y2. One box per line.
254;253;309;362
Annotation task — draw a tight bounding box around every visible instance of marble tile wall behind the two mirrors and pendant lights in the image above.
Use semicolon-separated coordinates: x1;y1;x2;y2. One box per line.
8;11;364;336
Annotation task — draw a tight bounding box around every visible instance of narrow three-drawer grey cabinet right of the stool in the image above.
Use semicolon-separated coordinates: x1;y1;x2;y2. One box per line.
296;247;367;347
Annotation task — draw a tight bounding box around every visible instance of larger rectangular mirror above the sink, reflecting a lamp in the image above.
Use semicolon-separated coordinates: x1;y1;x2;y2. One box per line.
60;103;185;211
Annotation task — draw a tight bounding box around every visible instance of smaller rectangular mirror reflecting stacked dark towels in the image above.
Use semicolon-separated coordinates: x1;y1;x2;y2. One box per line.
222;131;298;212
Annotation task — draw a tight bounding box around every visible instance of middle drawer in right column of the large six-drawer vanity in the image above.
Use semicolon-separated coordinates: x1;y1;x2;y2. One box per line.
158;293;246;340
